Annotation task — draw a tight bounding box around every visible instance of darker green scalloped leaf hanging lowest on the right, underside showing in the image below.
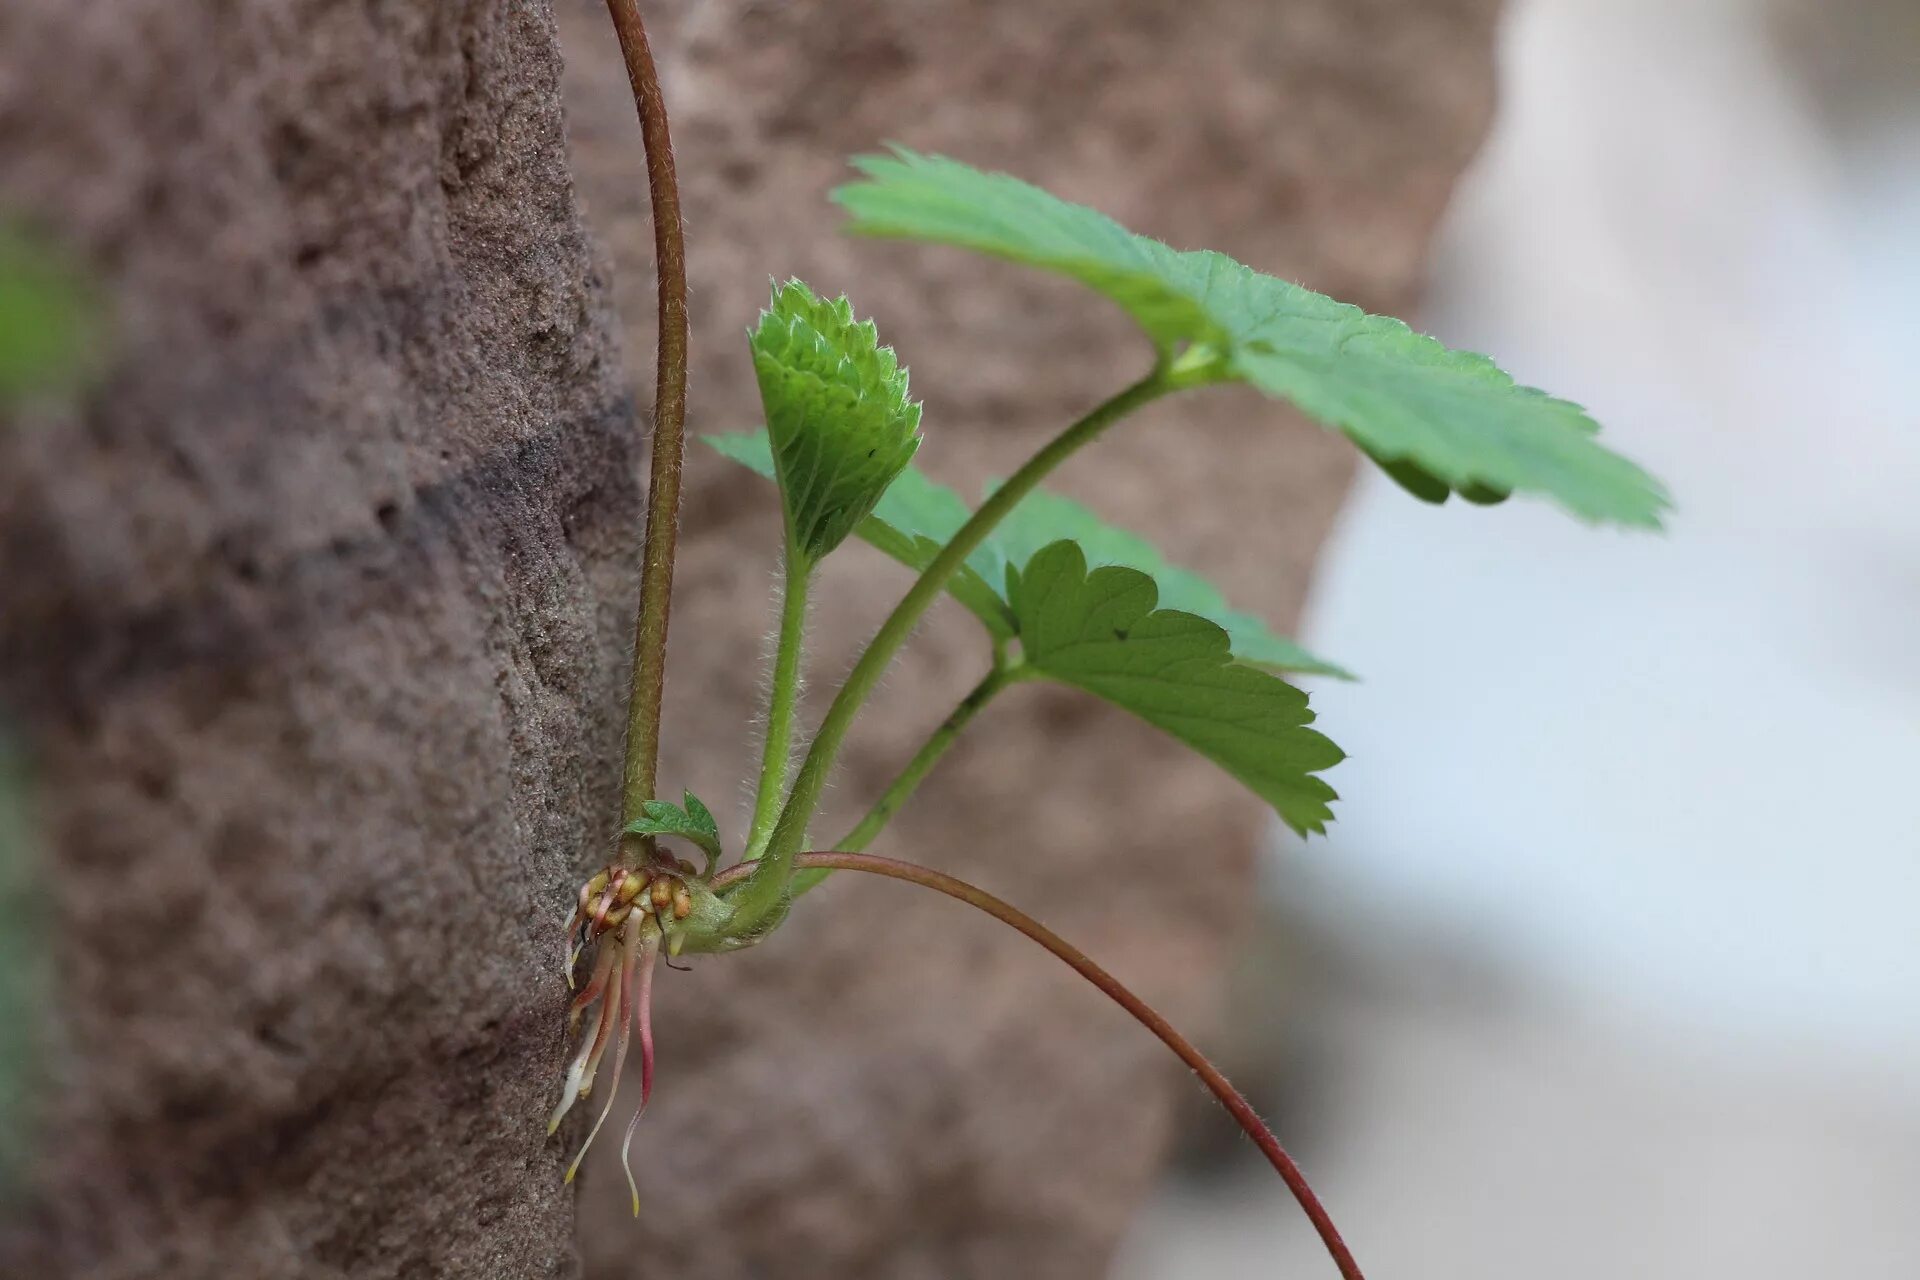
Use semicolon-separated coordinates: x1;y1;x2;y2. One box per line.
1010;541;1344;835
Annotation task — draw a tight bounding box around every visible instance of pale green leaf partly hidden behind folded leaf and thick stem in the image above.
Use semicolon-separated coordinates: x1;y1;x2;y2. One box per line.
705;432;1352;679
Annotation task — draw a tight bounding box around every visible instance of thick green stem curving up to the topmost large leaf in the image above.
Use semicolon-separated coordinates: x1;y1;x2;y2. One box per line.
733;368;1181;931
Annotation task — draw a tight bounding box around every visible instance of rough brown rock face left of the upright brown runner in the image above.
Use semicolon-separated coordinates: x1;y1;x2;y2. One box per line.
0;0;618;1280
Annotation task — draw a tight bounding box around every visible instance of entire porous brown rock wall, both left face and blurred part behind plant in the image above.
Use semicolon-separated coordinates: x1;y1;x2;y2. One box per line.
0;0;1494;1280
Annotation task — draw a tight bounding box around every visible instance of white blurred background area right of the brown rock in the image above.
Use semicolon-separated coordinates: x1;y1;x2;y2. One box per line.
1116;0;1920;1280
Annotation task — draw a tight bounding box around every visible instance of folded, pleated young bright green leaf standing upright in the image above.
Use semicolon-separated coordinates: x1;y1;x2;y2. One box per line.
749;280;920;564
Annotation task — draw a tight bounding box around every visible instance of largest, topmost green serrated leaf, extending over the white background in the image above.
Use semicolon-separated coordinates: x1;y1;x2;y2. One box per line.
833;150;1668;528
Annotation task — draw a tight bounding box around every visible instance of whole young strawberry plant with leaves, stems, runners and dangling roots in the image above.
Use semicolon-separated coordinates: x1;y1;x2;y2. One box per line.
553;10;1667;1278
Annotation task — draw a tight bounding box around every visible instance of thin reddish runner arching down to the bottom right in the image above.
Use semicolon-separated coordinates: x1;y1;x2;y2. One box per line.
714;852;1363;1280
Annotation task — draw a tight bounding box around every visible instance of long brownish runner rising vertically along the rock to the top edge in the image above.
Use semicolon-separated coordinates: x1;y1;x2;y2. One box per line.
607;0;687;827
